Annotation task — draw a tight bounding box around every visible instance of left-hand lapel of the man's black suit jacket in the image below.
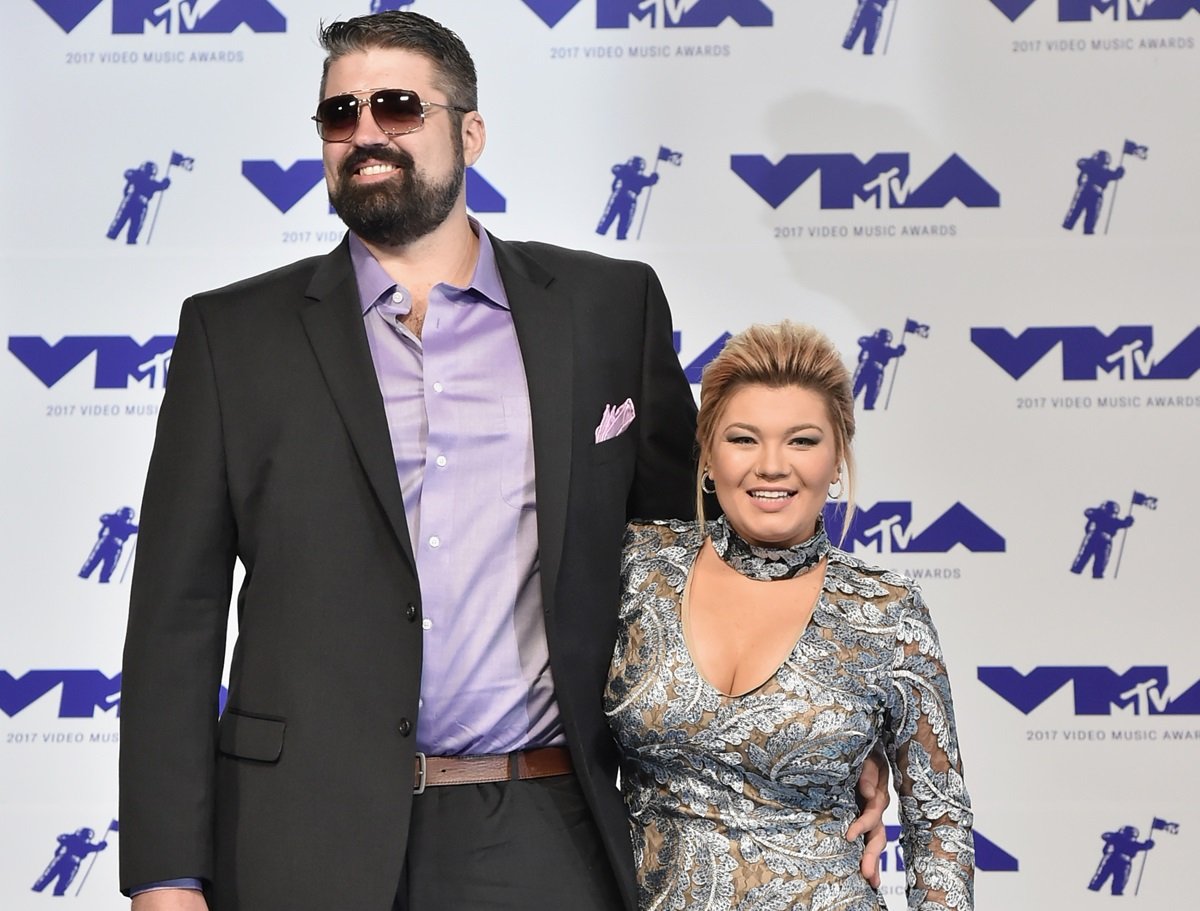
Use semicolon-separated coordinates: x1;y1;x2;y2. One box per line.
300;240;416;574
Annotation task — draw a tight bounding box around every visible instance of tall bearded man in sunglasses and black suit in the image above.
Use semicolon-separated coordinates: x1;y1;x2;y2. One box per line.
121;11;892;911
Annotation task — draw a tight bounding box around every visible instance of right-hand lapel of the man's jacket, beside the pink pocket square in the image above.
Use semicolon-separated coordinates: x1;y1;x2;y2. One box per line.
492;238;575;611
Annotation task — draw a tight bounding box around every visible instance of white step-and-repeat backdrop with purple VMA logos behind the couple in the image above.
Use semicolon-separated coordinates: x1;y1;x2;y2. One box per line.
0;0;1200;910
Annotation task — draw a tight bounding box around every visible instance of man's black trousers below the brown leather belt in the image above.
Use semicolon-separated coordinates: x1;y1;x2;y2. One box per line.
394;775;623;911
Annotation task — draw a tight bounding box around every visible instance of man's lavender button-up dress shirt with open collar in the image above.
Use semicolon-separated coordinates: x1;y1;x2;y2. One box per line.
350;226;565;756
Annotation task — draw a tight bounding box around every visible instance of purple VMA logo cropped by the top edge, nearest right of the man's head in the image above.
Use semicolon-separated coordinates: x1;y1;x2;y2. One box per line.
522;0;775;29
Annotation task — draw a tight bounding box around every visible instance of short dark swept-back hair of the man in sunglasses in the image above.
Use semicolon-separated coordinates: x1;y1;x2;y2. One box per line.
320;10;479;118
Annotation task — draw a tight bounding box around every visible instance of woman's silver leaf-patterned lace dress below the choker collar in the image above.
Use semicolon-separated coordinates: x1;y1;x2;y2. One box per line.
605;522;974;911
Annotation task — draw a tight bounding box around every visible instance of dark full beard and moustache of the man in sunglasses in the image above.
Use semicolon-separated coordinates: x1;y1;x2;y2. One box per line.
329;146;466;247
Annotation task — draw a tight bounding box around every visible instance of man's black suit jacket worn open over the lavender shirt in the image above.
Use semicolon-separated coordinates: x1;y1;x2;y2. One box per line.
120;240;695;911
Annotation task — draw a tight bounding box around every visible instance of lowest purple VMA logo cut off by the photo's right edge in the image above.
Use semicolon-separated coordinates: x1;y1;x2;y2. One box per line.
978;666;1200;715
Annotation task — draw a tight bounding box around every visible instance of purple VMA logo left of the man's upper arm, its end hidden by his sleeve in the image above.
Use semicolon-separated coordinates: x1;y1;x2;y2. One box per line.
8;335;175;389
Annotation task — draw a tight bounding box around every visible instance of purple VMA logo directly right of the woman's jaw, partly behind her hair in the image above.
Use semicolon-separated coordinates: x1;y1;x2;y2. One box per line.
824;501;1004;553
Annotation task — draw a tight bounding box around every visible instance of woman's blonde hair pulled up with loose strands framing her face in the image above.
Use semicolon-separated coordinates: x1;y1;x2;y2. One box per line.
696;319;854;529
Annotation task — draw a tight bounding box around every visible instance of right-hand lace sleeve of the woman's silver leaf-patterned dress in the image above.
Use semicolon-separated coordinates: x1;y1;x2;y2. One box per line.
884;588;974;911
